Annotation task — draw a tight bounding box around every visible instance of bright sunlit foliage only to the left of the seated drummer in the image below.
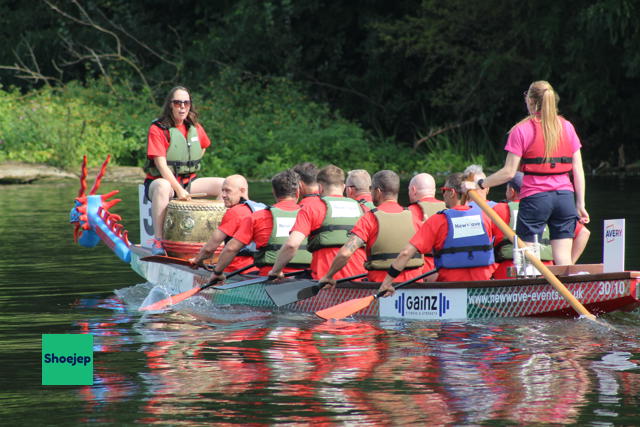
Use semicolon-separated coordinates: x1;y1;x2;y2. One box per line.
0;82;151;169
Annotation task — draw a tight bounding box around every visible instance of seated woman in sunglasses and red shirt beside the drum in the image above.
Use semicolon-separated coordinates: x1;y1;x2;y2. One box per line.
144;86;224;255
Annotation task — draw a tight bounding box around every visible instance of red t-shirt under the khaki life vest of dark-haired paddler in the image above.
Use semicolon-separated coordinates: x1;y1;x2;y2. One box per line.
351;201;423;282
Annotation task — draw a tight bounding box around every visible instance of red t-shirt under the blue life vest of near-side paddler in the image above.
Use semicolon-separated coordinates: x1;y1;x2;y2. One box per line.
410;205;497;282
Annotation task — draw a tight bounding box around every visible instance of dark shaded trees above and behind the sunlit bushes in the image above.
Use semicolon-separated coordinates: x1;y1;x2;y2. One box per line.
0;0;640;171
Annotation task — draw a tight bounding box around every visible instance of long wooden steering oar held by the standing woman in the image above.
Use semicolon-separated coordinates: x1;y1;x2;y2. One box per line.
468;190;596;320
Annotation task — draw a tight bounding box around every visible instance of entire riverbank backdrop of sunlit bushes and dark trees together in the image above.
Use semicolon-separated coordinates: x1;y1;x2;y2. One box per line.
0;0;640;178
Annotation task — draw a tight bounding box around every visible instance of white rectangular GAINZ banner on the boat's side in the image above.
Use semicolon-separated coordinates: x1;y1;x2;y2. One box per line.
380;289;467;320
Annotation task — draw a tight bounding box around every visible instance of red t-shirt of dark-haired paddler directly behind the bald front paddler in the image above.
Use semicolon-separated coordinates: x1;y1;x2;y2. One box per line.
233;200;300;276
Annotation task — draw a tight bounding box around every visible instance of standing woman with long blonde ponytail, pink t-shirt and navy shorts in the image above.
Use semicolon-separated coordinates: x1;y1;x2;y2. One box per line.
465;80;589;265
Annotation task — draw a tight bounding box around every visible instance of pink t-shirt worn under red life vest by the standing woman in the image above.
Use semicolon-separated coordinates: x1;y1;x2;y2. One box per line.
504;120;582;198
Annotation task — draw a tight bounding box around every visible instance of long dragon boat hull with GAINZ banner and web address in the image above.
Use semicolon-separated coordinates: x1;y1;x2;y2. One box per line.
131;244;640;320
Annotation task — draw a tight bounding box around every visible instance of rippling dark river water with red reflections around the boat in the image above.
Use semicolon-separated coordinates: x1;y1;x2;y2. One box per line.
0;179;640;426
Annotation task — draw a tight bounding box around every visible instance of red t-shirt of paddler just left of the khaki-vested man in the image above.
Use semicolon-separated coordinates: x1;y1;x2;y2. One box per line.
291;195;367;279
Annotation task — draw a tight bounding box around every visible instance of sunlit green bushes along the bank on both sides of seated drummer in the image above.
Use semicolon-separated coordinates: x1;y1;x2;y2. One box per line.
0;74;496;178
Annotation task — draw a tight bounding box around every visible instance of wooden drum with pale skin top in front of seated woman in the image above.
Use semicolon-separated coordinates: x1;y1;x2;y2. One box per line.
162;199;227;263
